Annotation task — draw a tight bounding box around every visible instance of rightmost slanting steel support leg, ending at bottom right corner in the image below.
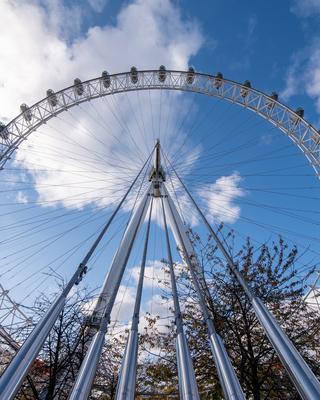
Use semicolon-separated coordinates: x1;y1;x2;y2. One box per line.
176;174;320;400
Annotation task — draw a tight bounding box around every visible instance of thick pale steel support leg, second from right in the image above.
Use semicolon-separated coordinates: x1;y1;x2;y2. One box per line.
165;193;245;400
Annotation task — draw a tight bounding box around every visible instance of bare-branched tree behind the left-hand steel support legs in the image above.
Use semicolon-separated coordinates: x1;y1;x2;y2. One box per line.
9;289;124;400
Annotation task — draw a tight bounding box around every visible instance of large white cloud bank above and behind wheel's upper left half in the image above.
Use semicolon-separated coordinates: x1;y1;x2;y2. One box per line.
0;0;203;207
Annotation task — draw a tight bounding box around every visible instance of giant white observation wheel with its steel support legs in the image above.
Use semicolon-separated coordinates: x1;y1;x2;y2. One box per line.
0;66;320;400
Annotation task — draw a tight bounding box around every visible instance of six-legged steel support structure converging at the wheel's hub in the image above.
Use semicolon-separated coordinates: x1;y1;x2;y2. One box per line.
0;141;320;400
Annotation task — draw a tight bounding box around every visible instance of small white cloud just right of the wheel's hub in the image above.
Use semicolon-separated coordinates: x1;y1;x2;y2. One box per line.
198;172;246;223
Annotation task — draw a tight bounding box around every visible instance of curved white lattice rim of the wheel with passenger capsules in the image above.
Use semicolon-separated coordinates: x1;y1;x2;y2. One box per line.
0;68;320;177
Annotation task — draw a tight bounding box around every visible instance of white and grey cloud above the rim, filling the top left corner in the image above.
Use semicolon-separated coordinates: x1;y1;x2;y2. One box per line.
0;0;202;118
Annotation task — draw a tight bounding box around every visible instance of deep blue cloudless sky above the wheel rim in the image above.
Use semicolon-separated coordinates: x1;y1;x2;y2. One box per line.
36;0;320;114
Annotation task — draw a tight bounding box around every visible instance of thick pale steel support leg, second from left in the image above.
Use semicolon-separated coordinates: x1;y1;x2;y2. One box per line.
69;190;151;400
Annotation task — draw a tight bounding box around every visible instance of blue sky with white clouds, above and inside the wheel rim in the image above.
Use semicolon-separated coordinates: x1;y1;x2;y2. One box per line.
0;0;320;328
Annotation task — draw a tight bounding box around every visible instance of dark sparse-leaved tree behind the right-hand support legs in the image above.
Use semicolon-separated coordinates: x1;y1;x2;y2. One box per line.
196;233;320;400
